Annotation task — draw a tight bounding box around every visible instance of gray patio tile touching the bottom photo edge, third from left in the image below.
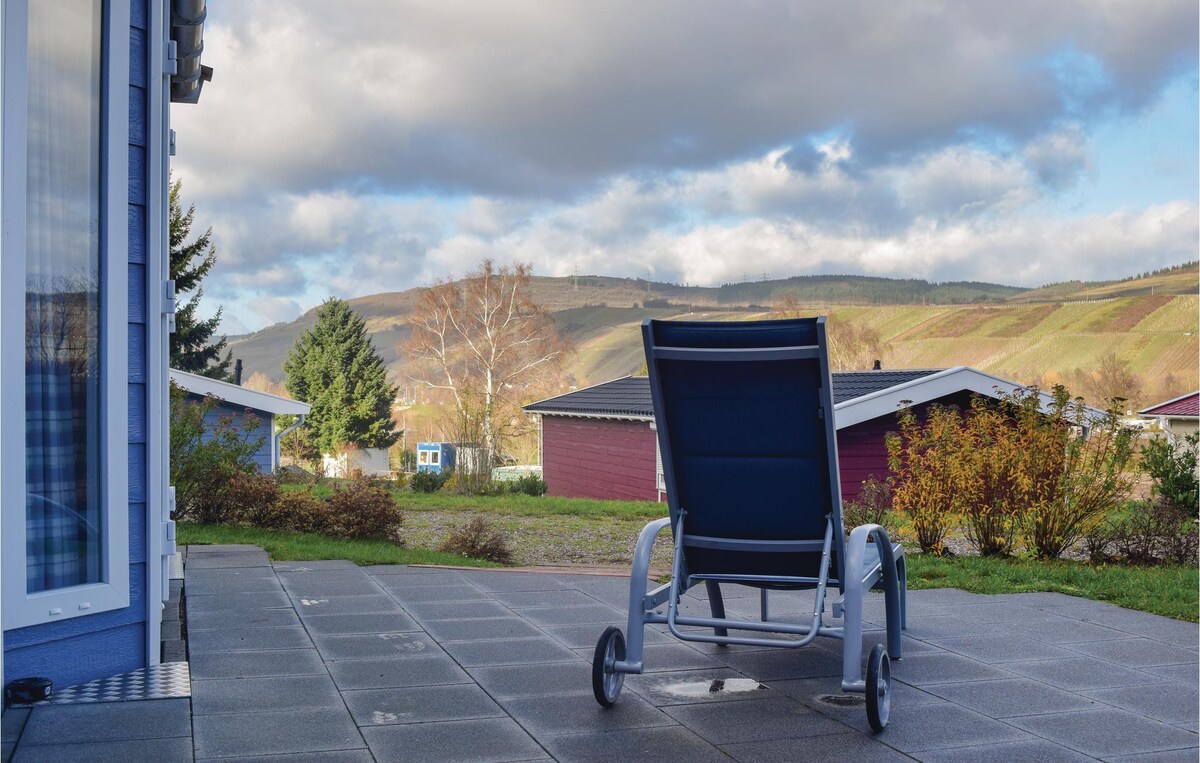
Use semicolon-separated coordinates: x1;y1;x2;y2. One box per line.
362;719;546;763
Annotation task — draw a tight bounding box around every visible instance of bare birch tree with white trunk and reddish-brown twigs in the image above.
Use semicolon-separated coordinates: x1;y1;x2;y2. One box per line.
402;259;565;459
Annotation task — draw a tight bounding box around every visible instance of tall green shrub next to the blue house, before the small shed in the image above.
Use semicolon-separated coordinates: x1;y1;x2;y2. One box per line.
170;384;264;523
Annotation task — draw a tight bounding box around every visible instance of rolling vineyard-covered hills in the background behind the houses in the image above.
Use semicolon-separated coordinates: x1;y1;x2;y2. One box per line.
230;263;1200;396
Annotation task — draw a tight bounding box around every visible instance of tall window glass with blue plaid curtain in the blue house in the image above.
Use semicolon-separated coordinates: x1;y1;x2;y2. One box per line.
25;0;103;593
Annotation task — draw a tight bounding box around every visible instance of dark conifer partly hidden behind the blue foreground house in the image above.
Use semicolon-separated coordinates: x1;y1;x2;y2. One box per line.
168;180;233;380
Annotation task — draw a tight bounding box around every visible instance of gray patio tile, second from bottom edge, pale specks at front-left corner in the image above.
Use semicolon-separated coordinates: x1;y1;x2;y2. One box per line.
342;684;504;726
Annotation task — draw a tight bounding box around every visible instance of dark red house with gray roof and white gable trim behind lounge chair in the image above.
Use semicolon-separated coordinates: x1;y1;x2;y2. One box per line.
524;366;1050;501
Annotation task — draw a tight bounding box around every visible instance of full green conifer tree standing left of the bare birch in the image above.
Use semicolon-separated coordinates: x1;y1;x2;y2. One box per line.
283;298;400;456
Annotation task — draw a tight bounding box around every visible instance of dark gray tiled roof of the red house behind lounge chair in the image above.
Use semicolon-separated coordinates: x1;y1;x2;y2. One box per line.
524;368;940;419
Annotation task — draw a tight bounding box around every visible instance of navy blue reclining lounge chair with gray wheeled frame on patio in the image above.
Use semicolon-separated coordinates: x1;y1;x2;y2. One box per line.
592;318;905;731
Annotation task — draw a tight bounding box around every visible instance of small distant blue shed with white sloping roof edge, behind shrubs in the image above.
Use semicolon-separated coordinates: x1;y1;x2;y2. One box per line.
170;368;312;474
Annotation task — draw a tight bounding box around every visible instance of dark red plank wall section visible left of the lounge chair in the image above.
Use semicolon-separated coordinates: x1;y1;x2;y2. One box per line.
541;416;658;500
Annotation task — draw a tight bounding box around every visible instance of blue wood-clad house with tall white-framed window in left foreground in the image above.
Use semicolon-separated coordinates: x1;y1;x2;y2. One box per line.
0;0;210;687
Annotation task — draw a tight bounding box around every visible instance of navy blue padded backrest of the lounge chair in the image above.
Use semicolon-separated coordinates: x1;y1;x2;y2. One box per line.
642;317;844;587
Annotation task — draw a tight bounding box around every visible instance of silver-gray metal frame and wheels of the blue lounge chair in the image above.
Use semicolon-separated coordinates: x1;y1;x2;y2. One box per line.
594;317;907;731
